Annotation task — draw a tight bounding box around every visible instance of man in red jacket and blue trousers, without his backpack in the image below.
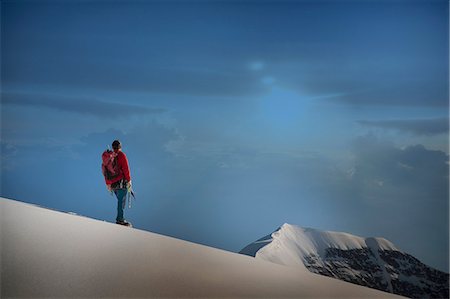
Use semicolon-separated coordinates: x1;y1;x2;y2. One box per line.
107;140;131;226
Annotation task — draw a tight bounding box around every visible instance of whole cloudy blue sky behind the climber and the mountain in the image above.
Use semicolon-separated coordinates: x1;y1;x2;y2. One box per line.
1;0;449;271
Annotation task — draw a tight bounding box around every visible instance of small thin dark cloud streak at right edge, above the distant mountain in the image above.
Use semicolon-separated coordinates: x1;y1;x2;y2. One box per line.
358;117;449;136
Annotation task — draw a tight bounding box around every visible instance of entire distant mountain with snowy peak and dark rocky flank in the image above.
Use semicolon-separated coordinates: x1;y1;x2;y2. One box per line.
240;224;449;298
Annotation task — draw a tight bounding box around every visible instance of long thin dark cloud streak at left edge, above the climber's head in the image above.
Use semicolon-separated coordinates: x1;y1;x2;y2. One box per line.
1;93;165;118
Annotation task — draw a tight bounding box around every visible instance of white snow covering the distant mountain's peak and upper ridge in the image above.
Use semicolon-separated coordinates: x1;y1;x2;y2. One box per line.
253;223;399;270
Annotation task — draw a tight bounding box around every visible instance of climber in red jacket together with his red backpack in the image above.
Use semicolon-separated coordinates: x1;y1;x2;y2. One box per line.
102;140;133;226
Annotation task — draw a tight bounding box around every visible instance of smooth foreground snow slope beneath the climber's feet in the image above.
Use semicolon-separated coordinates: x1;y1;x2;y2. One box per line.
0;198;395;298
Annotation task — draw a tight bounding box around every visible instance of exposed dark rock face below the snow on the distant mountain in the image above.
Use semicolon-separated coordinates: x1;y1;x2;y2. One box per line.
304;248;449;298
